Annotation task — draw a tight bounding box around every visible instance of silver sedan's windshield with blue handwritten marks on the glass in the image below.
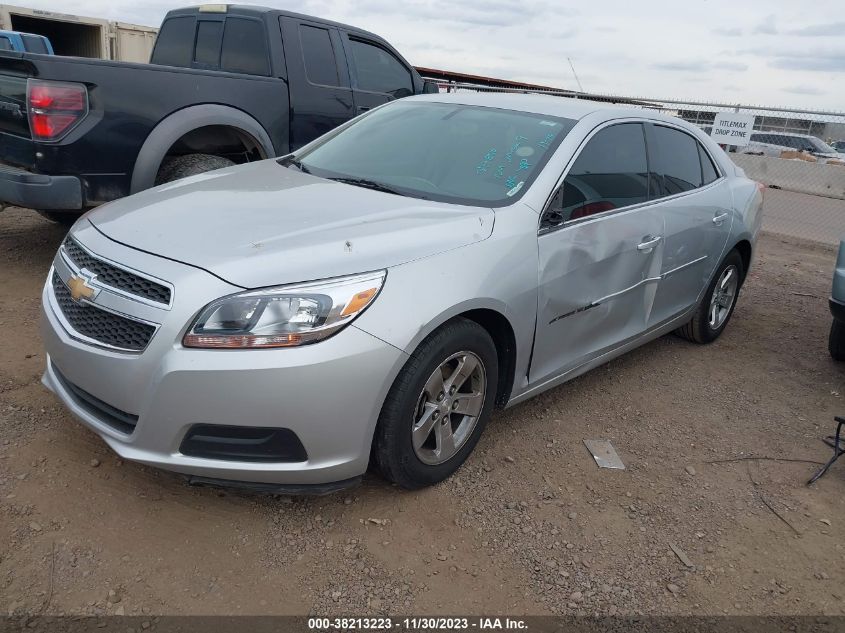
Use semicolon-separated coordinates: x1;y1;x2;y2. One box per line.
295;101;575;207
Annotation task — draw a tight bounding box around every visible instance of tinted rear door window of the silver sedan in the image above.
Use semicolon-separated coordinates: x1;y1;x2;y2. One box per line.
651;125;701;197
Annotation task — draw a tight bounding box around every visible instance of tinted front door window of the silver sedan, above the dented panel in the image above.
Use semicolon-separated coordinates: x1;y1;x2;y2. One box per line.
543;123;649;226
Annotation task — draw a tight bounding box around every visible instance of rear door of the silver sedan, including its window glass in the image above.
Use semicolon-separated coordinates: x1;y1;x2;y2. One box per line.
646;123;733;326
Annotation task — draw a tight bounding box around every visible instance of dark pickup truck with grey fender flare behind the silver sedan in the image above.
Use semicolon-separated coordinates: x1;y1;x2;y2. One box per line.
0;5;437;221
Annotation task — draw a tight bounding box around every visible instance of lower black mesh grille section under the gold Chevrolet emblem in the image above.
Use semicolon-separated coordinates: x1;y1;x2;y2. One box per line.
52;272;156;352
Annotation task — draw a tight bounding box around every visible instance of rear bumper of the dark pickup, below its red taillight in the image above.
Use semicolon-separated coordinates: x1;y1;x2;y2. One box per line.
0;163;82;211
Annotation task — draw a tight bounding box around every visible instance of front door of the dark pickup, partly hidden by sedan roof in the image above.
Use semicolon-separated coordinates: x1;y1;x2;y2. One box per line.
342;32;414;114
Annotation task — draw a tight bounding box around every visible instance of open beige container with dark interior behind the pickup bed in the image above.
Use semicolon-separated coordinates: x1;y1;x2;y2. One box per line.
0;4;158;62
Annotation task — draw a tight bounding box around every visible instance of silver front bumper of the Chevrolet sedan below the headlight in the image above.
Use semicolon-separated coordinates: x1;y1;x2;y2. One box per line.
42;225;407;492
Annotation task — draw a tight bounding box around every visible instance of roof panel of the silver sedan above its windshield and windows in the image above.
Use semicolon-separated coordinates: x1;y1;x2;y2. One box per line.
403;91;695;128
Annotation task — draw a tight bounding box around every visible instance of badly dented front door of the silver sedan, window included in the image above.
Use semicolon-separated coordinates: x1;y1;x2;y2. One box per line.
529;123;663;384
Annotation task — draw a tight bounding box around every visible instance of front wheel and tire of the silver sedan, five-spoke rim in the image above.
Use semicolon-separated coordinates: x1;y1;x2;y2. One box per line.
373;318;499;490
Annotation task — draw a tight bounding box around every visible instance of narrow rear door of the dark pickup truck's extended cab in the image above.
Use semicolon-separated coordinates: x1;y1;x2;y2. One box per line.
279;16;354;151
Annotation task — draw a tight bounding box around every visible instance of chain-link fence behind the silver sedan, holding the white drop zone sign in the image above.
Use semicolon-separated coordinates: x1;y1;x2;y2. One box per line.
432;78;845;245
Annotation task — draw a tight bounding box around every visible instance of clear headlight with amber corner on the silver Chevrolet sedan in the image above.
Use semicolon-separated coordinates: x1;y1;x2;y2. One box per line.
182;270;387;349
